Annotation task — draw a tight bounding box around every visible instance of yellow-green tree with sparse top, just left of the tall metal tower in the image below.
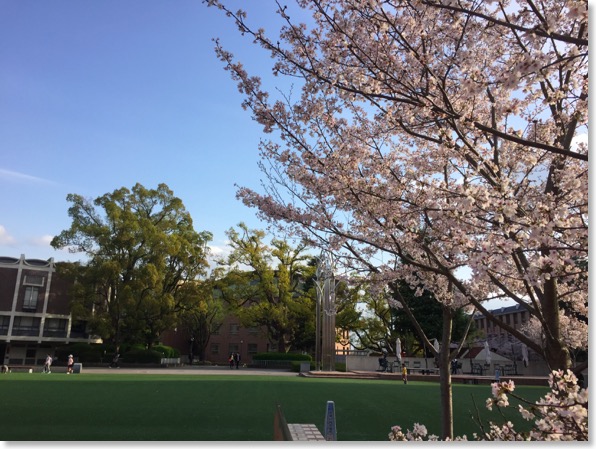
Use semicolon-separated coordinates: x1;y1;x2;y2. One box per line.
214;223;314;352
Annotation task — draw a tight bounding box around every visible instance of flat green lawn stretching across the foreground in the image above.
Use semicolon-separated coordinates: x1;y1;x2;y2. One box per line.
0;373;547;441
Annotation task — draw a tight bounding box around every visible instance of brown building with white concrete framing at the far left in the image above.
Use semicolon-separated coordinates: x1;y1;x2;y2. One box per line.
0;255;100;365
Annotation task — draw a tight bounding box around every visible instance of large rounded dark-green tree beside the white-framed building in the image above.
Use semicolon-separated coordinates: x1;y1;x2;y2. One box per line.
52;184;211;346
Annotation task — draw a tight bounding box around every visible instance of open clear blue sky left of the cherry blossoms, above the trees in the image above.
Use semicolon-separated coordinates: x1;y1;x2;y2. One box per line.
0;0;288;260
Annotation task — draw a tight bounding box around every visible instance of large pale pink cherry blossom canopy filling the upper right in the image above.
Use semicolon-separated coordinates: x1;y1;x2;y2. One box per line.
208;0;588;437
